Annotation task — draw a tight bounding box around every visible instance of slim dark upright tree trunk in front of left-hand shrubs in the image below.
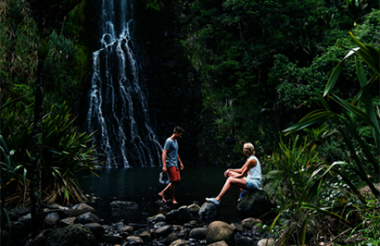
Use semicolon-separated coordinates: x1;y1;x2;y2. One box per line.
30;59;44;235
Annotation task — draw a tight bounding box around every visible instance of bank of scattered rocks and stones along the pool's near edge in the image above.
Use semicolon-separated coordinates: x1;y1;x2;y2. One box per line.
0;188;274;246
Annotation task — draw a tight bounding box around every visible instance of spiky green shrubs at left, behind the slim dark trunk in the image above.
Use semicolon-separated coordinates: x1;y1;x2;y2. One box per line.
0;100;99;205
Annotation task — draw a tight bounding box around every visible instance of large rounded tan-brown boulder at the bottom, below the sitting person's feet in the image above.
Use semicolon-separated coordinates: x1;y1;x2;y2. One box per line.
206;221;234;244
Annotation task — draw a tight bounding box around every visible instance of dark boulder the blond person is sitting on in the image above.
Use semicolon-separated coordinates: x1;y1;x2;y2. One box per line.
237;190;274;216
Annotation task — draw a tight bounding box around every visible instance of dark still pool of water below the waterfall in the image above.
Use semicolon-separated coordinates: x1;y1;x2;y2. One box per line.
79;166;249;223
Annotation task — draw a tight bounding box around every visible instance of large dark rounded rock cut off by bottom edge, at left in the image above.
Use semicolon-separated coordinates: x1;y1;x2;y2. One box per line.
45;224;99;246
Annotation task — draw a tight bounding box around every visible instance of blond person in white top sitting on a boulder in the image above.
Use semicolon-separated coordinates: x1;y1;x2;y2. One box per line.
206;143;262;205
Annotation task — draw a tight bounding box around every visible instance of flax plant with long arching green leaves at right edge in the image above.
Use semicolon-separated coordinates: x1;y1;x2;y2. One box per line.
272;33;380;245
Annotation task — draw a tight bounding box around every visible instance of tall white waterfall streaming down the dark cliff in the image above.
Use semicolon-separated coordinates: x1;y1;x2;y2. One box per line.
87;0;162;167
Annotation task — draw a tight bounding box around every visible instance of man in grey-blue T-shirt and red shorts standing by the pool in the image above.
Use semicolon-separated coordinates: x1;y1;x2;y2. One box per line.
158;126;185;204
